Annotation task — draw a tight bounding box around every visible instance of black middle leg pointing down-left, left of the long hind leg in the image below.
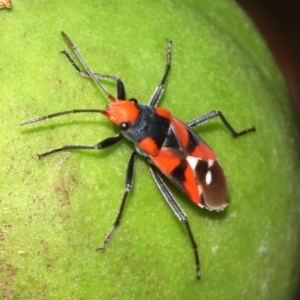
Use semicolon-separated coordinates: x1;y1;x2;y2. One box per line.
97;151;137;251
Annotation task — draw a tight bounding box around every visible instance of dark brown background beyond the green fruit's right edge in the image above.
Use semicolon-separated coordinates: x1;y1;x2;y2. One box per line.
236;0;300;300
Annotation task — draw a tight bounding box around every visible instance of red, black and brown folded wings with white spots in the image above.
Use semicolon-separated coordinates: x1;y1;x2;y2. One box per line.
150;118;228;210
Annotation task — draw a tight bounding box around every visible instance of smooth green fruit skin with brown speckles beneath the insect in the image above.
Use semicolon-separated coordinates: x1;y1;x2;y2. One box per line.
0;0;300;300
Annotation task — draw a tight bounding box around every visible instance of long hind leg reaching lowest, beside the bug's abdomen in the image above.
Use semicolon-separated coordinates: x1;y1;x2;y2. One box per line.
150;166;201;280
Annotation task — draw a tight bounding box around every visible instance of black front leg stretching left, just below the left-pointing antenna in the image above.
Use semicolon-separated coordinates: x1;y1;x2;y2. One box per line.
38;134;123;158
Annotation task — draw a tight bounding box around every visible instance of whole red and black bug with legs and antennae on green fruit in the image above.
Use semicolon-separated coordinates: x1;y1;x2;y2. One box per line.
20;32;255;279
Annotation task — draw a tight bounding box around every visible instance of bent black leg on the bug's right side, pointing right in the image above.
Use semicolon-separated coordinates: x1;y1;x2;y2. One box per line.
186;110;256;138
